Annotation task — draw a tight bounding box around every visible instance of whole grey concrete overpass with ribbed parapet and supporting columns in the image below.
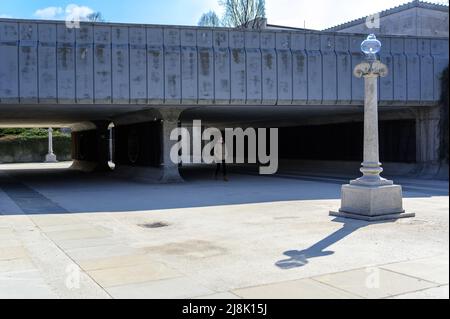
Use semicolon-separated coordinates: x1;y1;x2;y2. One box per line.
0;19;449;181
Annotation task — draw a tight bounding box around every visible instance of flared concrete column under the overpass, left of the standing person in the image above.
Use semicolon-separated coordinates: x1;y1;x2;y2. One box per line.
159;108;183;183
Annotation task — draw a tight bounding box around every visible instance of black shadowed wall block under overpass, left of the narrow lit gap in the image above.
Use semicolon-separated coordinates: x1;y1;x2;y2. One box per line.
72;121;111;172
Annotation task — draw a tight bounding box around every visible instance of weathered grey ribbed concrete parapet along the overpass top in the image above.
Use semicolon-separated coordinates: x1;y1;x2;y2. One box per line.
0;20;448;105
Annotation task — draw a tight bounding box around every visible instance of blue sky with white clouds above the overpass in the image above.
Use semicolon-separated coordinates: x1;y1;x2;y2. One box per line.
0;0;448;29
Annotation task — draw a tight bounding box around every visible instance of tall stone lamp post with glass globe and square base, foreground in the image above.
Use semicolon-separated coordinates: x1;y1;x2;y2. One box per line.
330;34;414;221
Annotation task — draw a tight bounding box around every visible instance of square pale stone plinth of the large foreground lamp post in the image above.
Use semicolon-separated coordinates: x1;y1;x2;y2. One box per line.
330;184;415;221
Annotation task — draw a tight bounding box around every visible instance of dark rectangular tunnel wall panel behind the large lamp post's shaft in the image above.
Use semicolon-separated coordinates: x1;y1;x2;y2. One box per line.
279;120;416;163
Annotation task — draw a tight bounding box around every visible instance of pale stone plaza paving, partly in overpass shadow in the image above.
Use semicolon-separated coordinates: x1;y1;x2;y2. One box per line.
0;163;449;299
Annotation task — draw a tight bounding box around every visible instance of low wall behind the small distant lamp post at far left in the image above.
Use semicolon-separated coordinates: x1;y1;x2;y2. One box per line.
0;136;71;163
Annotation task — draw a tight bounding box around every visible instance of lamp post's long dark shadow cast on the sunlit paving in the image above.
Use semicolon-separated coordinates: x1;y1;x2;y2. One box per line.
275;218;392;269
